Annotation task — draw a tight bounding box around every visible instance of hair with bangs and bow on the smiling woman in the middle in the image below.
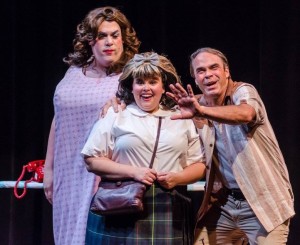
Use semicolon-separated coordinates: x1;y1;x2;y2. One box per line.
116;52;181;109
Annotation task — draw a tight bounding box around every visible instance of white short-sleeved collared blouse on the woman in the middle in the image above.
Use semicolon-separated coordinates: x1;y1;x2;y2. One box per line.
81;103;205;172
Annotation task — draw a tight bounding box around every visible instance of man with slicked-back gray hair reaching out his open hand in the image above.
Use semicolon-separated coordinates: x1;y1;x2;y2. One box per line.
167;48;295;245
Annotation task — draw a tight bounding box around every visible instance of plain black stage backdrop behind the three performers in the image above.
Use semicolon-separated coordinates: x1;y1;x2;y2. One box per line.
0;0;300;245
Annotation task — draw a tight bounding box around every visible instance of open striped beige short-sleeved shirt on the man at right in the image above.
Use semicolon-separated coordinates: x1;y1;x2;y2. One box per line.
195;81;295;232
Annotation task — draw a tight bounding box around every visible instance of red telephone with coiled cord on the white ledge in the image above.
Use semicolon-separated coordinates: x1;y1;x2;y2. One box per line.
14;160;45;199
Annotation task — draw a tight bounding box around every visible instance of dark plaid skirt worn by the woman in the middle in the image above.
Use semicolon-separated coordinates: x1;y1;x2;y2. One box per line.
86;185;193;245
